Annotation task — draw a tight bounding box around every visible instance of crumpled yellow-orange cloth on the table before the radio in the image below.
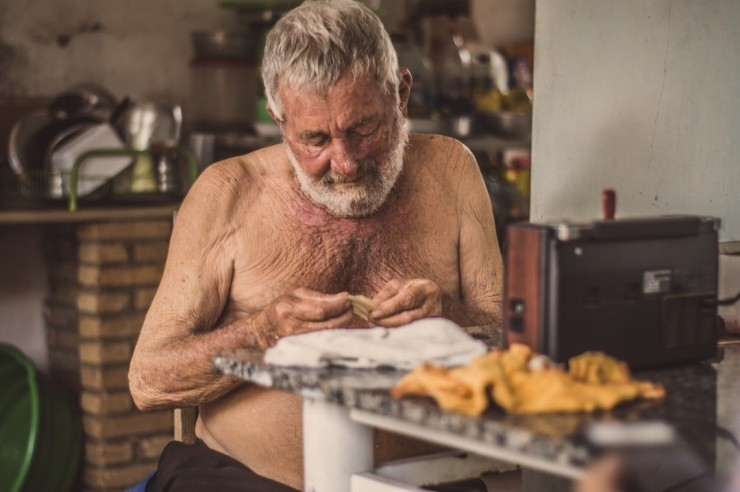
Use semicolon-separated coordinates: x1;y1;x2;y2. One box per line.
391;344;665;416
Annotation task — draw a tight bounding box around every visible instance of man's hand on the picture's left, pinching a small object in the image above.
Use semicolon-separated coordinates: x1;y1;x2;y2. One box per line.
266;288;352;341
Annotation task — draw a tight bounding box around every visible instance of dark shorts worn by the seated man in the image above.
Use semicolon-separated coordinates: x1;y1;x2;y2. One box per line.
146;441;296;492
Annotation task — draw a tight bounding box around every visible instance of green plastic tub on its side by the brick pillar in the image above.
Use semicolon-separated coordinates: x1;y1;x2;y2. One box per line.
0;343;82;492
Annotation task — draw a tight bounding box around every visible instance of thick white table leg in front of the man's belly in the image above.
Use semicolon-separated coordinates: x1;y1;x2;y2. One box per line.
303;398;373;492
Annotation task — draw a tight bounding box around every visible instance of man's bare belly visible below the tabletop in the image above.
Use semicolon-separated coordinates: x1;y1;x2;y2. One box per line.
196;385;442;490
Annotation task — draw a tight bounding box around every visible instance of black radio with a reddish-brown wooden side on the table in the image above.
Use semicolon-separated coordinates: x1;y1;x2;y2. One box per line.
504;216;719;368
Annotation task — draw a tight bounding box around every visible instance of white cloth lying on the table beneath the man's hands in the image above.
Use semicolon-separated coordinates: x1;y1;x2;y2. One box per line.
265;318;488;370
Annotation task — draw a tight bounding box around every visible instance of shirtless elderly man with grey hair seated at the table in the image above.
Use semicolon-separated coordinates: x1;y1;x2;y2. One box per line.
130;0;502;491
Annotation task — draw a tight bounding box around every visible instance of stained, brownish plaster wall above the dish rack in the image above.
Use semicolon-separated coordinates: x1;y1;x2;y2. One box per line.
0;0;239;108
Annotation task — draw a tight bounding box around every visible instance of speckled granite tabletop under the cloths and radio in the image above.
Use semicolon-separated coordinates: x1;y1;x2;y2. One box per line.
214;341;740;474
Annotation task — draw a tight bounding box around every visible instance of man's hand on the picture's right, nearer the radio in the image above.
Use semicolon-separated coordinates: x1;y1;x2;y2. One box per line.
370;278;442;328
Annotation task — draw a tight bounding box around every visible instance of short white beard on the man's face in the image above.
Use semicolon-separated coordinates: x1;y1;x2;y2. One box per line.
285;111;409;217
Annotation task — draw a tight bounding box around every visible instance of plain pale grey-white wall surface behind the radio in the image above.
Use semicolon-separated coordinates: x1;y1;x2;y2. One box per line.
532;0;740;241
